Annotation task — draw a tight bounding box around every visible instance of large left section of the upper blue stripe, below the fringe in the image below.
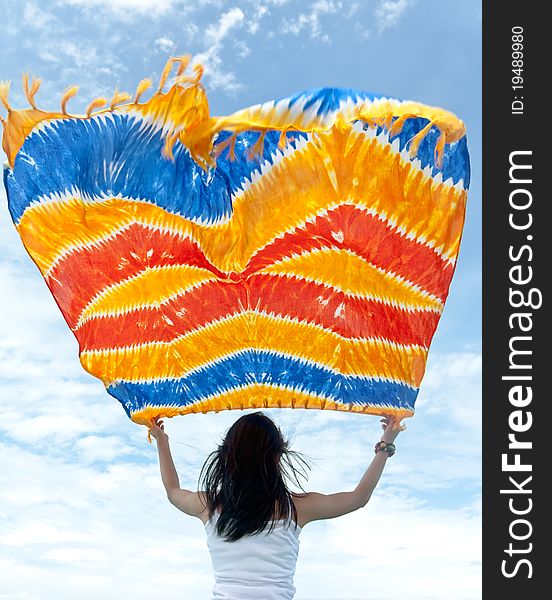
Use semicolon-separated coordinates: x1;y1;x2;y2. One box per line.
6;114;232;223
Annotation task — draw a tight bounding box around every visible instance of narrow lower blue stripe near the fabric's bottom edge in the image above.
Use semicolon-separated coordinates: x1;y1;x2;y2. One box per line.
107;349;418;416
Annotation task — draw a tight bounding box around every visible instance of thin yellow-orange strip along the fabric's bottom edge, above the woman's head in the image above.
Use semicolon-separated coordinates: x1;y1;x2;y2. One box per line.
131;383;414;426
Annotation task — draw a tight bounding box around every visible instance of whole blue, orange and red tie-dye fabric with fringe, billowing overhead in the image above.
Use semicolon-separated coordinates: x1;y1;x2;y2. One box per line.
0;57;469;424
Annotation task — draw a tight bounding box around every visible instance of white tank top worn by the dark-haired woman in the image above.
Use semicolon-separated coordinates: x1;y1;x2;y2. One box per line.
205;512;301;600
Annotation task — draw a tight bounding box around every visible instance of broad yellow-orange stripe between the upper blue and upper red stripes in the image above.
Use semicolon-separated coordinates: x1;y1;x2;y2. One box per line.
18;131;466;272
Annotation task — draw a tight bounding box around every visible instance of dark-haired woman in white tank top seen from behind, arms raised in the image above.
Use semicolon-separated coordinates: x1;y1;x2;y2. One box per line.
151;412;401;600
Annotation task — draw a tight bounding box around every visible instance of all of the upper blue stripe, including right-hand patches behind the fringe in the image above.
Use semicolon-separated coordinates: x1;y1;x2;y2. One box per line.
4;88;470;224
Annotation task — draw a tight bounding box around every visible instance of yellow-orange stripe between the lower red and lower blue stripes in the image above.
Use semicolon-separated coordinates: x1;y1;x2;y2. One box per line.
80;311;427;387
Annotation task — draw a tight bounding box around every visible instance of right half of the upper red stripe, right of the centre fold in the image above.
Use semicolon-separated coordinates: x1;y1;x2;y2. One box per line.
244;204;454;301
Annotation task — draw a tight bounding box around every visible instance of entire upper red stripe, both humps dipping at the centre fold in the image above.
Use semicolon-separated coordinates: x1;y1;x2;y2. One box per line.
47;205;453;328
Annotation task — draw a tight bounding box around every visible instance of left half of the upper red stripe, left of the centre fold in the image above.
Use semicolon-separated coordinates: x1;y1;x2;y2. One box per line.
46;223;224;328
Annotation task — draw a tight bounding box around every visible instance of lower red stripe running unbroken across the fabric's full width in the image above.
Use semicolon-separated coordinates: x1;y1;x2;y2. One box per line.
76;275;440;350
